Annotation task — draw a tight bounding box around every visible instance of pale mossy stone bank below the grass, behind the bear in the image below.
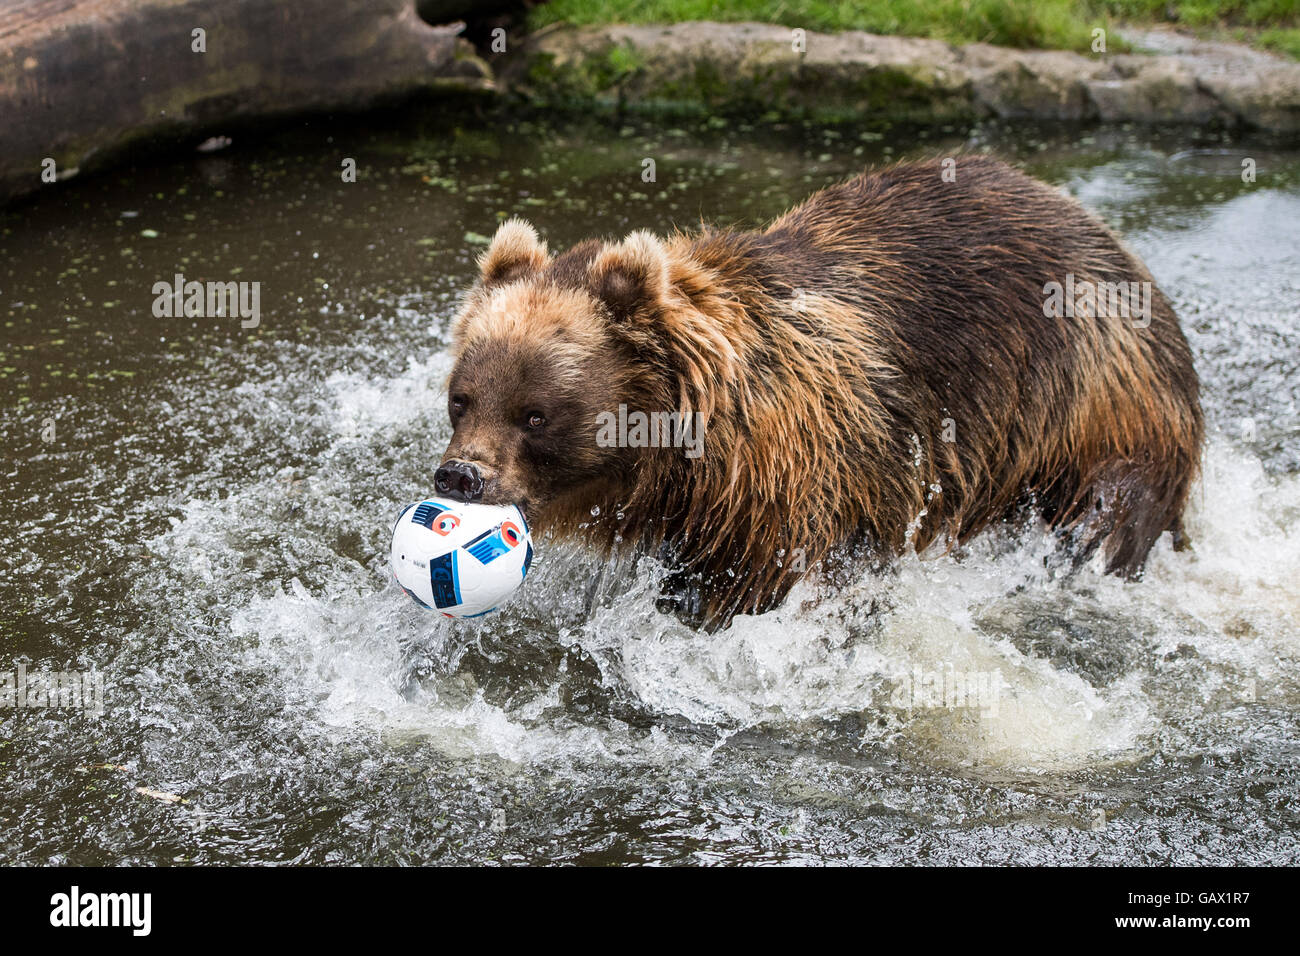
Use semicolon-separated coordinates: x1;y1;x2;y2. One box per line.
503;22;1300;134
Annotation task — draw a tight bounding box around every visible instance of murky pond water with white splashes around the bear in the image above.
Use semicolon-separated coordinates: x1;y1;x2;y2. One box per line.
0;116;1300;864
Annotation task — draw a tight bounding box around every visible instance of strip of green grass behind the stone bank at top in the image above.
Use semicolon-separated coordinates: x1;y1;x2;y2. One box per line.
532;0;1300;59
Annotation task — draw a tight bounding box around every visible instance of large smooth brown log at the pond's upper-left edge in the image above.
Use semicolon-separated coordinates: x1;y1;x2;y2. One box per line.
0;0;489;200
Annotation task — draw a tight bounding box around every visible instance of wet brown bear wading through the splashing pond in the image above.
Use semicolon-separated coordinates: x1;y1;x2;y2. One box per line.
436;157;1204;630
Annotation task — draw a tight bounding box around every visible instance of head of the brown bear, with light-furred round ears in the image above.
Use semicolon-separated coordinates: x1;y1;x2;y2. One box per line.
436;219;703;528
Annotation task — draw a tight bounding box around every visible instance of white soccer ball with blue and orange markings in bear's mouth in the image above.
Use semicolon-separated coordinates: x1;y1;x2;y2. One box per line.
391;498;533;618
